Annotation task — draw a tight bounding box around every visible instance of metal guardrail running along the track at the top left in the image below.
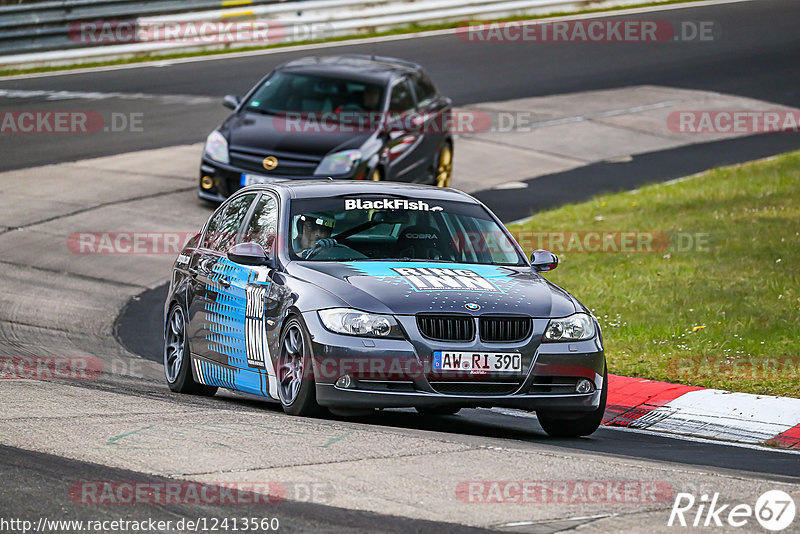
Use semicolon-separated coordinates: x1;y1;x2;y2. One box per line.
0;0;664;67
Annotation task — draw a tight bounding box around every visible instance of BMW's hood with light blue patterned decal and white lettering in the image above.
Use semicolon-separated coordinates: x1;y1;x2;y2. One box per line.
293;261;580;317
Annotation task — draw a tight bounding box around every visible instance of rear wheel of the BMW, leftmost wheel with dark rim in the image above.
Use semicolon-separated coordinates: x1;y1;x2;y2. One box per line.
164;304;217;397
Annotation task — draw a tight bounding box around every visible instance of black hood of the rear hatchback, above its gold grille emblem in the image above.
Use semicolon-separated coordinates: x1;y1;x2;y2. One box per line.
225;111;373;158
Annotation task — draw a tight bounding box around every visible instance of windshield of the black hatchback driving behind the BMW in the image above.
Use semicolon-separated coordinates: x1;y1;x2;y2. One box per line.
246;71;384;113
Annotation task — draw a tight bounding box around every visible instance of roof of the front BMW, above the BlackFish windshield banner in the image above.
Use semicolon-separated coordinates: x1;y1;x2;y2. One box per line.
240;180;480;204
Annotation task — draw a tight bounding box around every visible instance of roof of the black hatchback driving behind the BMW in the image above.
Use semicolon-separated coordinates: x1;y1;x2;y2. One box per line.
276;54;422;83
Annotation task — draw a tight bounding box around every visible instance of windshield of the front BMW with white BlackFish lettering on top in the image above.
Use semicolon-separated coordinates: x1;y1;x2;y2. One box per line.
288;195;525;265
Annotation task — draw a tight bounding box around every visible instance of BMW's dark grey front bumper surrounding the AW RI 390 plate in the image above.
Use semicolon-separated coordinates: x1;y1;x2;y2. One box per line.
303;312;605;412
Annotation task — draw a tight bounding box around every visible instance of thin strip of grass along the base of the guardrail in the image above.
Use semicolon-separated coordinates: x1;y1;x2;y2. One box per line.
0;0;702;77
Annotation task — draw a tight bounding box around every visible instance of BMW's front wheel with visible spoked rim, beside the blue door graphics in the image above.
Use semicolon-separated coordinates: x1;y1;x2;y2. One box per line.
276;317;323;417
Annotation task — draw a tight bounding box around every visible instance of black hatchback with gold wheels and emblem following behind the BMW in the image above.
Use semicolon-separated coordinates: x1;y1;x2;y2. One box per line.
198;55;453;201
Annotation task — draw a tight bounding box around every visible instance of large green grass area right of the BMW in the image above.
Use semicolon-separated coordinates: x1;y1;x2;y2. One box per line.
512;152;800;397
